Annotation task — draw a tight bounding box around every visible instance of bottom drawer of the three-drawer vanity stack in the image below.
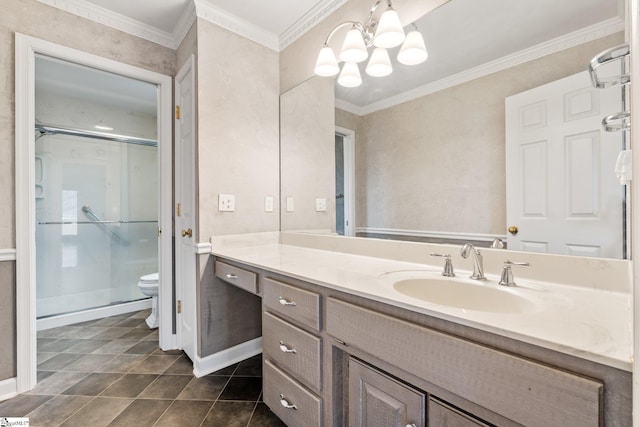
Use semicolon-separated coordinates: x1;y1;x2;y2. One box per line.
262;359;322;427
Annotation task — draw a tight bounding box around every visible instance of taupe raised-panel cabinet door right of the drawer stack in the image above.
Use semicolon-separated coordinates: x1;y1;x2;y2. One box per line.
348;358;424;427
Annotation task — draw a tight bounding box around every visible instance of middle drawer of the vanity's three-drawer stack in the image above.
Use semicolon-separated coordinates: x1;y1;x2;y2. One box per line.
262;312;322;390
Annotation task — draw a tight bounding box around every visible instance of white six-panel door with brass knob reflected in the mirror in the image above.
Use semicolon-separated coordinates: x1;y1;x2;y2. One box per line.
506;71;624;258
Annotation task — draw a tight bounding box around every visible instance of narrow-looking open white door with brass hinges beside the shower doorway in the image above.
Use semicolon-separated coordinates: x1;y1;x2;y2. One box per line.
175;56;197;361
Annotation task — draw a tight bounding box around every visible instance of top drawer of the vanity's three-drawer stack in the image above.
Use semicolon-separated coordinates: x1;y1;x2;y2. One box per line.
262;279;320;331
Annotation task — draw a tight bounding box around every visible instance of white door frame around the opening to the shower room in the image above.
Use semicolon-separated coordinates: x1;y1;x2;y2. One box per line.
15;33;176;393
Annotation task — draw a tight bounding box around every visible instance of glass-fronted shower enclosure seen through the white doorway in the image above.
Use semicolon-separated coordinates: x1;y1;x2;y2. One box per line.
34;56;159;319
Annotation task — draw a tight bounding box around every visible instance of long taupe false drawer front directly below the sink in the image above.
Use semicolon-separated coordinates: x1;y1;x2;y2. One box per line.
326;298;603;427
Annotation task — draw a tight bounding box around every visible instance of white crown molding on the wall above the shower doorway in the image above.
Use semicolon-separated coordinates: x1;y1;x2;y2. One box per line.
38;0;176;49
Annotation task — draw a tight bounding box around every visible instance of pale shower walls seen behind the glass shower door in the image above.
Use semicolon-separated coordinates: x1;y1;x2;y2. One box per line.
35;87;158;317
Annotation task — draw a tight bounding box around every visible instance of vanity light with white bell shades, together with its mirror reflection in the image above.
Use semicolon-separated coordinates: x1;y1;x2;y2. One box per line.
314;0;428;87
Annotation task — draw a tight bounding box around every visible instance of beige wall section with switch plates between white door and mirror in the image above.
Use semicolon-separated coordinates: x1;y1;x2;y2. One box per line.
197;19;280;242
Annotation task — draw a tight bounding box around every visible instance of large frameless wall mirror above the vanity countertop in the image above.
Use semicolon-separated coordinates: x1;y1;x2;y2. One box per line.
281;0;628;258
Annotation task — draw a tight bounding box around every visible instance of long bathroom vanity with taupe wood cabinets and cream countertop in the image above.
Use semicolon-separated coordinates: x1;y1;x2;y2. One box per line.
209;236;631;427
